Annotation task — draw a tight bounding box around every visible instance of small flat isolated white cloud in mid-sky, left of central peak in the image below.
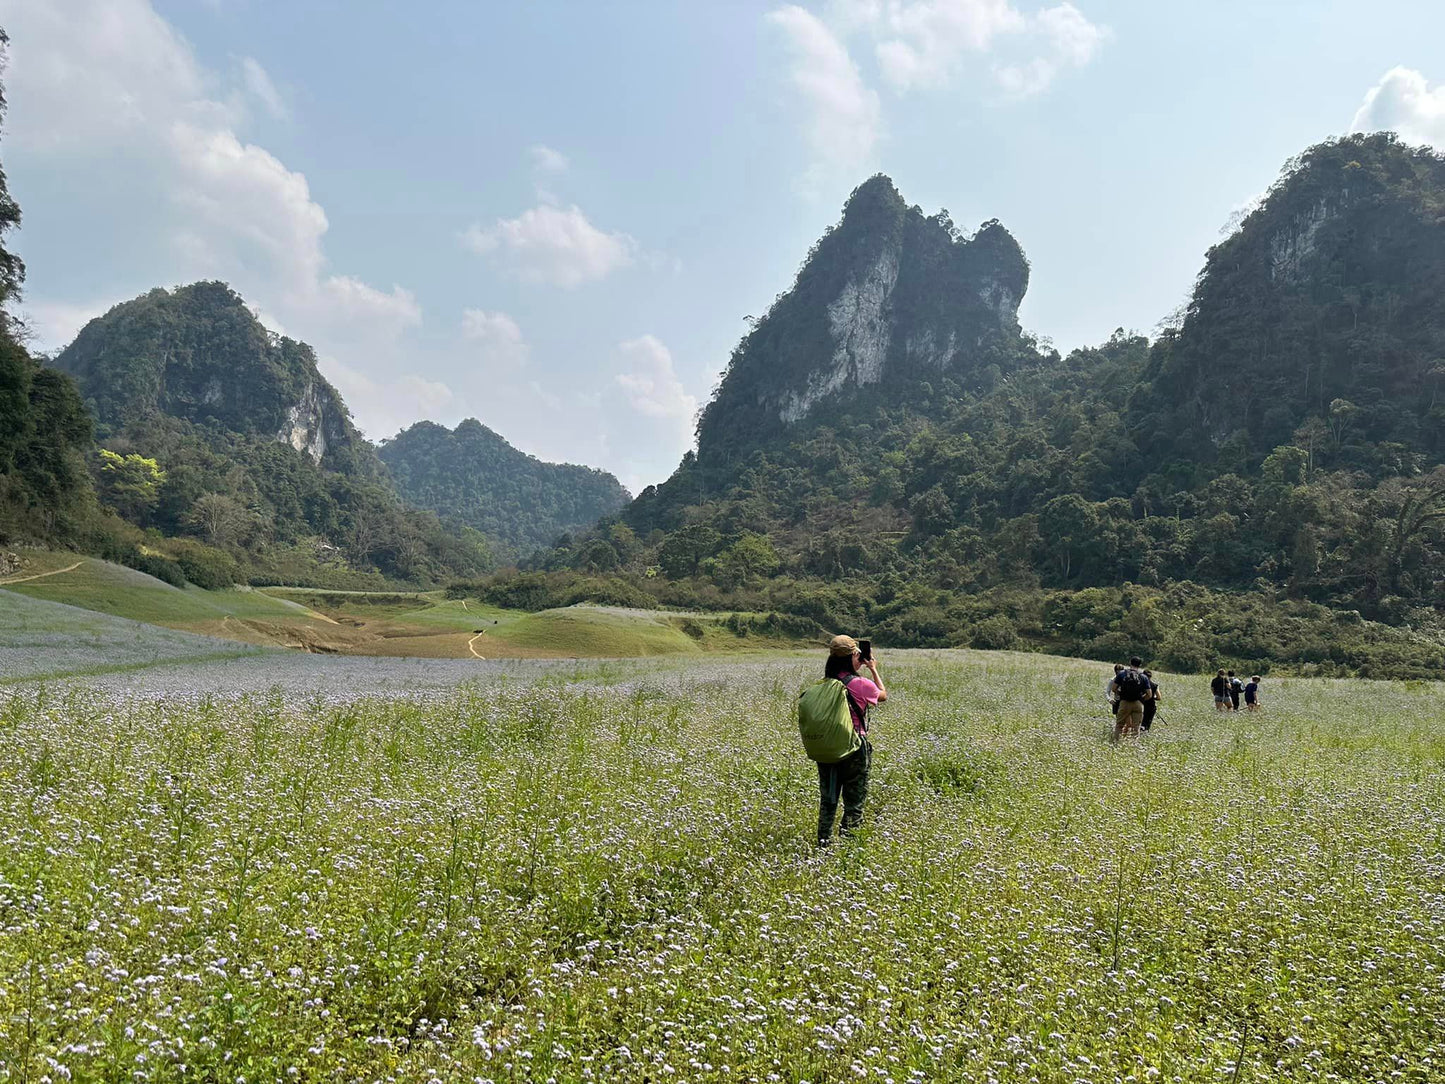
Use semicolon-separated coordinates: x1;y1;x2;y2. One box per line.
462;204;637;286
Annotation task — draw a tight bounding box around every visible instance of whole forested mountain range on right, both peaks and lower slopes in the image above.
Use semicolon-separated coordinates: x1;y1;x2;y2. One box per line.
493;134;1445;672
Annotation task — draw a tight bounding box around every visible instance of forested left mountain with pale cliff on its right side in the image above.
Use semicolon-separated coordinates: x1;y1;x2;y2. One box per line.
55;282;491;582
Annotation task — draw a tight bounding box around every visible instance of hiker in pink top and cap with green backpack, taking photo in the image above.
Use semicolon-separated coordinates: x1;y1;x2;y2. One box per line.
798;636;889;847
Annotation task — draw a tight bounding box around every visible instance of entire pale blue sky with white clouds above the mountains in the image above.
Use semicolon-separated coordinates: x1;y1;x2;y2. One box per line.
0;0;1445;491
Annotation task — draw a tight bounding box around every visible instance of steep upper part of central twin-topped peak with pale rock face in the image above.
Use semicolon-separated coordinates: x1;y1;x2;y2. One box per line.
698;176;1029;460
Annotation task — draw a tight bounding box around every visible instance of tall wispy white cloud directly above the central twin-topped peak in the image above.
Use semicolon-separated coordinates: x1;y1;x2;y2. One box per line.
767;4;880;182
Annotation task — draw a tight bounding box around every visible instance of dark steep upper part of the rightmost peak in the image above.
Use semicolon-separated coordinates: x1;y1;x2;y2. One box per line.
1140;134;1445;473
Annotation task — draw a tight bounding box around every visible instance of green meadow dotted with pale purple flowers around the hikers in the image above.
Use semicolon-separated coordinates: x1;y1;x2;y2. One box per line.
0;652;1445;1084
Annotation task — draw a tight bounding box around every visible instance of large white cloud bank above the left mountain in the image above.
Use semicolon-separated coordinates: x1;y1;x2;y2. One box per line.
6;0;422;413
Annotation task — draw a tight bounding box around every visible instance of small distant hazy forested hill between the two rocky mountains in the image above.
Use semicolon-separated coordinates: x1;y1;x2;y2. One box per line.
380;418;629;555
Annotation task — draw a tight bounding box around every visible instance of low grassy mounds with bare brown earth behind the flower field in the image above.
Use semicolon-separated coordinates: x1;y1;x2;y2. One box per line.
0;551;814;659
